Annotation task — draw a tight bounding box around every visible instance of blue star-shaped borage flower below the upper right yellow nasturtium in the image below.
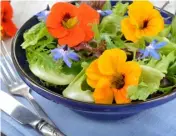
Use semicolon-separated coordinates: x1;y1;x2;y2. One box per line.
139;40;167;60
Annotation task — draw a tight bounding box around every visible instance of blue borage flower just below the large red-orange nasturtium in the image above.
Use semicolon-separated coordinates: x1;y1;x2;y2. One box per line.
51;45;80;68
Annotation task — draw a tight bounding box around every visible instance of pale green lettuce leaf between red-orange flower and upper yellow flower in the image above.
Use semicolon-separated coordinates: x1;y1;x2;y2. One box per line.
92;15;125;49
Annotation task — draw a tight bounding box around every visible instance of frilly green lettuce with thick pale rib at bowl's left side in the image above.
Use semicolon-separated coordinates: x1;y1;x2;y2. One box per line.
22;22;82;85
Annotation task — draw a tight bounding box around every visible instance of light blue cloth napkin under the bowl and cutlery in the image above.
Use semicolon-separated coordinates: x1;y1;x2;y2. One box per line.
0;55;176;136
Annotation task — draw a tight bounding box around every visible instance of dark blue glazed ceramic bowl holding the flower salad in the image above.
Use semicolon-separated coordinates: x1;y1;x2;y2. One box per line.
11;2;176;119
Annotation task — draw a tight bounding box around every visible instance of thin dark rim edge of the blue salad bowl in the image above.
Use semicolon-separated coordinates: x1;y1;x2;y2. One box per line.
11;8;176;108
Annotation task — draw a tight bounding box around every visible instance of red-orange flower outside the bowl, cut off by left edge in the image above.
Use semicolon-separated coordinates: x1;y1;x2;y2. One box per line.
0;1;17;37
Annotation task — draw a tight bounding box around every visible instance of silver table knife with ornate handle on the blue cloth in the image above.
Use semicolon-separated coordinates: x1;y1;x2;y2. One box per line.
0;91;65;136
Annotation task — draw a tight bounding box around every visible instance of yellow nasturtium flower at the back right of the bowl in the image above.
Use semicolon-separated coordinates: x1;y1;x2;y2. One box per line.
121;1;164;42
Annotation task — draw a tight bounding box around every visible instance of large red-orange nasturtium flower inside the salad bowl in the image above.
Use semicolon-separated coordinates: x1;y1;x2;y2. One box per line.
46;2;100;47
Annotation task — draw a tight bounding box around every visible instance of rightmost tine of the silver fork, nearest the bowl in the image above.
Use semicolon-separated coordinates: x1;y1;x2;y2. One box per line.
1;41;18;82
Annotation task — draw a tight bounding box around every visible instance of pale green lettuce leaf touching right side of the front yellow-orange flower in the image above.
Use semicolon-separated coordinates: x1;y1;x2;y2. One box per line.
128;65;165;101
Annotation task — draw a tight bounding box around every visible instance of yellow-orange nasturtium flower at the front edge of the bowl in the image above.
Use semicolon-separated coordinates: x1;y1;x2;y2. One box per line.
86;49;141;104
